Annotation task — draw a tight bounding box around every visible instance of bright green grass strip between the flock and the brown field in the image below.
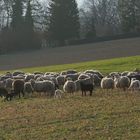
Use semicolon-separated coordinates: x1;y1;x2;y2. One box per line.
1;56;140;73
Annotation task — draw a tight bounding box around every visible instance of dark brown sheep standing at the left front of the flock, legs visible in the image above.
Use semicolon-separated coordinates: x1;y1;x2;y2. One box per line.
12;79;24;98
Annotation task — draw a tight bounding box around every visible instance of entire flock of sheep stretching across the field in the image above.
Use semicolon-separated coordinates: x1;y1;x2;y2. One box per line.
0;70;140;100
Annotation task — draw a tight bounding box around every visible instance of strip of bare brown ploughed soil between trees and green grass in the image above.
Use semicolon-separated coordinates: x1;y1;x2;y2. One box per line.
0;38;140;70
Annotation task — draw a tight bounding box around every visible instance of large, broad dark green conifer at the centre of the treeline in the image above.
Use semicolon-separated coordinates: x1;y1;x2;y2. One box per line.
48;0;80;45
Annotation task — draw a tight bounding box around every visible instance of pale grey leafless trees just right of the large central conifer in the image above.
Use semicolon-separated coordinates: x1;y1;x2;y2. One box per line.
83;0;119;36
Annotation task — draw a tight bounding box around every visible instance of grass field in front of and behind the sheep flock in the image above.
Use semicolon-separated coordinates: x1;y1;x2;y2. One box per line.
0;56;140;140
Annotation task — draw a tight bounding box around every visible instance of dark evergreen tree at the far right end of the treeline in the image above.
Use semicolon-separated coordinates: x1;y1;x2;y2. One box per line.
118;0;140;32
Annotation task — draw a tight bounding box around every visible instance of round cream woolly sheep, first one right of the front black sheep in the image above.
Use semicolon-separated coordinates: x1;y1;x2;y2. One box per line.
101;77;114;89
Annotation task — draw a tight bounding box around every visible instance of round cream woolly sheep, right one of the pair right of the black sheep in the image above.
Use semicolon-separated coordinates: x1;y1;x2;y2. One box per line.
114;76;130;91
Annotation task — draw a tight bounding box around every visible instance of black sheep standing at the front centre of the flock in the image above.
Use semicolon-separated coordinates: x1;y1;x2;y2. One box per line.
80;78;94;96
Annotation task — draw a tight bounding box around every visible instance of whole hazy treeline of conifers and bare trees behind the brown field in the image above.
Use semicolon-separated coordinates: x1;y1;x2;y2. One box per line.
0;0;140;53
